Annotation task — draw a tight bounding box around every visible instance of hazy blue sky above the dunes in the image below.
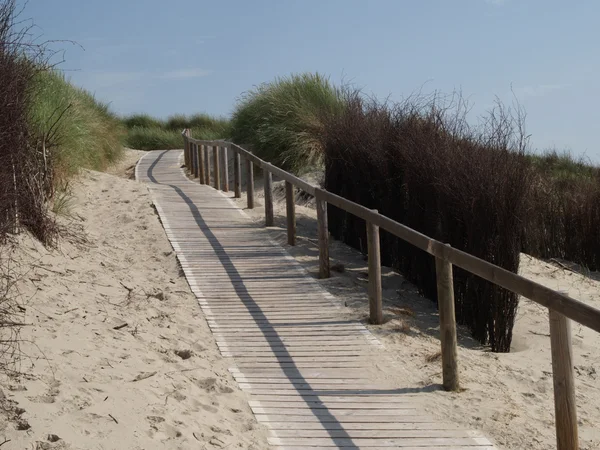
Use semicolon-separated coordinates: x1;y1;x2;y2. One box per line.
24;0;600;162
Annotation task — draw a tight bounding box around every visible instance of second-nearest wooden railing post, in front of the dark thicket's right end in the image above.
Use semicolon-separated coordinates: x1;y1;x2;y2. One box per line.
435;246;459;391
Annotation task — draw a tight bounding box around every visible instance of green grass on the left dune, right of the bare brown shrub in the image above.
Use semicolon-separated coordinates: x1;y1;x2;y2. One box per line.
30;71;125;186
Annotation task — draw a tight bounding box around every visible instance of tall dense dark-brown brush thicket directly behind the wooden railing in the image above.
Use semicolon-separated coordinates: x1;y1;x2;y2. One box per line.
323;92;530;352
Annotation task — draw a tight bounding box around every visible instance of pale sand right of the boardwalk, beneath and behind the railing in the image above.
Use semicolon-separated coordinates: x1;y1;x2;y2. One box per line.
230;175;600;450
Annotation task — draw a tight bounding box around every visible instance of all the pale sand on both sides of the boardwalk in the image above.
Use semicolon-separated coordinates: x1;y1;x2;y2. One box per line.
0;151;600;450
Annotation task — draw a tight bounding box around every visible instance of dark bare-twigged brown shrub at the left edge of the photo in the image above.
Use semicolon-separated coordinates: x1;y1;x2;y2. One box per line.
0;0;56;243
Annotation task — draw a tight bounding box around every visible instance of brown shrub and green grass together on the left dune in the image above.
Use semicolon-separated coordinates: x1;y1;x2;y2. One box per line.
0;0;125;245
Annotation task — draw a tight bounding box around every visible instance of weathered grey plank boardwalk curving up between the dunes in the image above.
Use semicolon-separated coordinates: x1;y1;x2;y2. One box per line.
136;150;495;450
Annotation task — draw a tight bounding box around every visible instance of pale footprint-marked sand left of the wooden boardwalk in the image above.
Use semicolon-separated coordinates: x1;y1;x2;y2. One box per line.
0;151;268;450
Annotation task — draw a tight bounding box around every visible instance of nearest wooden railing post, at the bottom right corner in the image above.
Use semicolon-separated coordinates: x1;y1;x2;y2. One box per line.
549;309;579;450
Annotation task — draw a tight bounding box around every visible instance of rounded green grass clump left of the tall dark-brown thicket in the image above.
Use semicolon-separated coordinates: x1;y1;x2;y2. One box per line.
232;73;344;173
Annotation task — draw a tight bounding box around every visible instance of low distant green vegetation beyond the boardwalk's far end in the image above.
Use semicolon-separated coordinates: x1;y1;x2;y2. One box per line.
123;114;230;150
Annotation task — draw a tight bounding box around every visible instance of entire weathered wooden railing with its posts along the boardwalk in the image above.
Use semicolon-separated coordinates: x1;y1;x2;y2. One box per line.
183;130;600;450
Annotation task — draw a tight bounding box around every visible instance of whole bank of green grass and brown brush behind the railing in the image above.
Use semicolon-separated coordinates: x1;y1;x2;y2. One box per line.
231;74;600;352
